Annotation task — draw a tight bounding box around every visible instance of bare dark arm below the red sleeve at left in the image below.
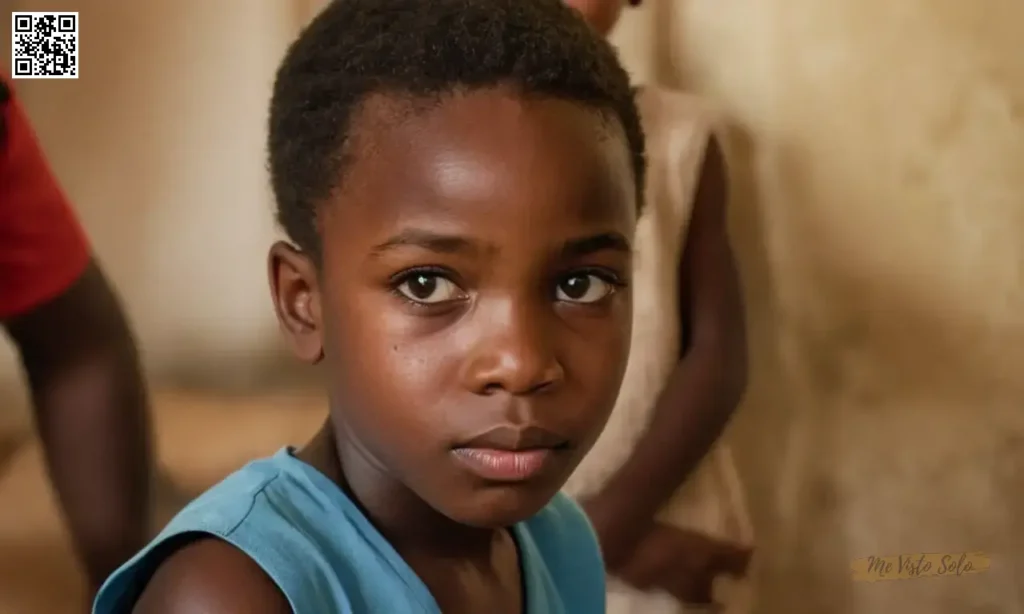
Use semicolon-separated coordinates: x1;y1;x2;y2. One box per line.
3;263;150;593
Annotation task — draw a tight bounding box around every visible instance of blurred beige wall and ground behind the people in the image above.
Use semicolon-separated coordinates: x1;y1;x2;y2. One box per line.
0;0;1024;614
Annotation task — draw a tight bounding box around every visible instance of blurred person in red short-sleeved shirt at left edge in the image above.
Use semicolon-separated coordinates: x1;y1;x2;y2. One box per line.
0;74;151;594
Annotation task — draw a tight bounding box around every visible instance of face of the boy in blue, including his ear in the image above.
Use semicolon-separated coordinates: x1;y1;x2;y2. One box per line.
271;89;636;527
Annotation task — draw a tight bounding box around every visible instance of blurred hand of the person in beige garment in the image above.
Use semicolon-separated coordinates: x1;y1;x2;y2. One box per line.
613;523;753;605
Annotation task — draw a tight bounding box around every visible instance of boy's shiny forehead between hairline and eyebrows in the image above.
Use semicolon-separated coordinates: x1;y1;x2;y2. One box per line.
329;91;635;248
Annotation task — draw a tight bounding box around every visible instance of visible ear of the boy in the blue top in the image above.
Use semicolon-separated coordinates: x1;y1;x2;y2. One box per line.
267;242;324;364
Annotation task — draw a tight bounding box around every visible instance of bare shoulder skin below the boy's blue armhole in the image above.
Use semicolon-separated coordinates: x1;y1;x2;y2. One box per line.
132;537;292;614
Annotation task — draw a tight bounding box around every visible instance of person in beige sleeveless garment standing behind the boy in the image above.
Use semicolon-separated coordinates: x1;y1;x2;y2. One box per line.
566;0;753;614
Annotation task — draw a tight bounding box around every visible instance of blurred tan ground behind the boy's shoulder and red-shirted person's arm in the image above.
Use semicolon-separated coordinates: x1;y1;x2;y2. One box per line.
0;394;325;614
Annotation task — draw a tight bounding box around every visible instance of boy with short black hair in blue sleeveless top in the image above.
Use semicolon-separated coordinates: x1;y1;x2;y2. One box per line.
94;0;644;614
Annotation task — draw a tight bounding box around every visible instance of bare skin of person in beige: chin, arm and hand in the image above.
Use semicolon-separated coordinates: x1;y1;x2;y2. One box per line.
566;0;751;604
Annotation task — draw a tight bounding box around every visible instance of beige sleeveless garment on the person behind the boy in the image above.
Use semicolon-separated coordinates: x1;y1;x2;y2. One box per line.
566;88;753;614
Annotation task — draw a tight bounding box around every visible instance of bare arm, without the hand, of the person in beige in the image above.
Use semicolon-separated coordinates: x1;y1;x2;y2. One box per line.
587;139;748;566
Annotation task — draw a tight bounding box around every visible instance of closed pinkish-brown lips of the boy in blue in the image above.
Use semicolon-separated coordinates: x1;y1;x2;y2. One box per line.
452;425;568;482
